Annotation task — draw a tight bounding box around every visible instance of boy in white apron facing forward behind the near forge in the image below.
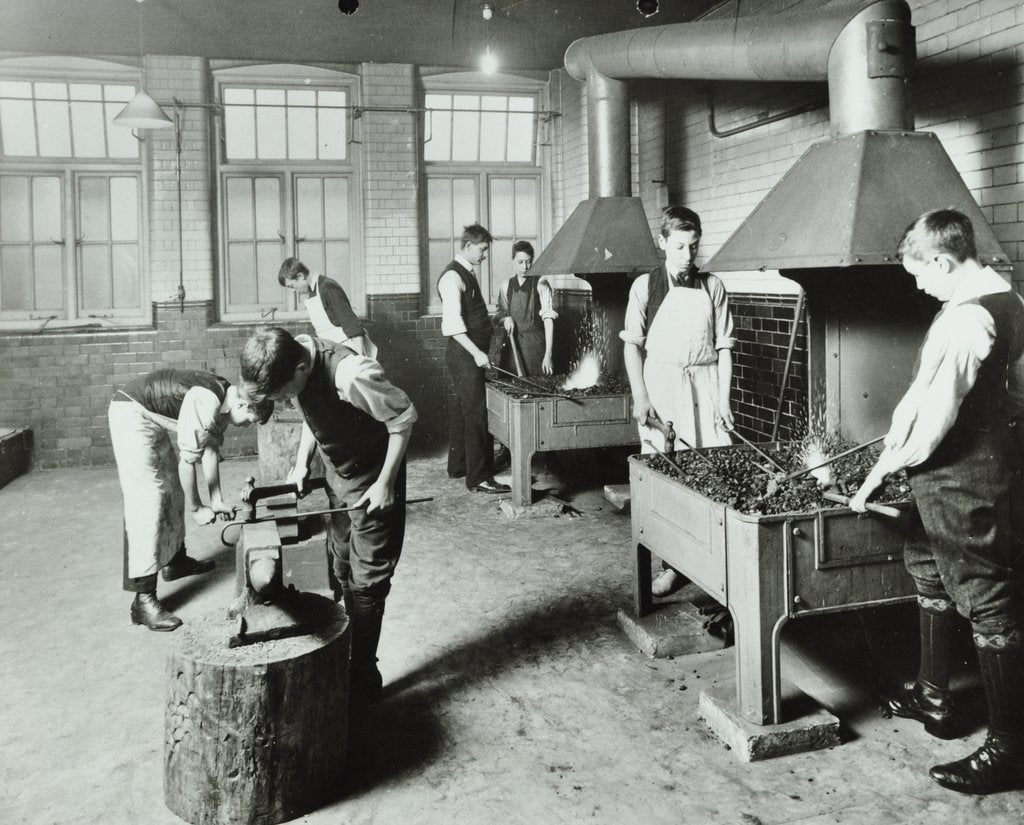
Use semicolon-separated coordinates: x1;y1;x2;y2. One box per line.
618;207;735;596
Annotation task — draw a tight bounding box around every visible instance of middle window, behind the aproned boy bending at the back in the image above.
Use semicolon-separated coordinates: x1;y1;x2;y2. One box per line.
217;67;364;320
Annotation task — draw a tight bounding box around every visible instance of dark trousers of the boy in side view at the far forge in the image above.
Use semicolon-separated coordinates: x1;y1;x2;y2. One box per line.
444;338;495;487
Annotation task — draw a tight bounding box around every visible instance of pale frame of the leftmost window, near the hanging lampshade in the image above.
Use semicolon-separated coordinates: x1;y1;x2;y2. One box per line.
0;56;153;332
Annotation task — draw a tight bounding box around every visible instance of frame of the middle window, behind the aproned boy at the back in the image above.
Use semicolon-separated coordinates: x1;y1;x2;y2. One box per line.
212;63;367;323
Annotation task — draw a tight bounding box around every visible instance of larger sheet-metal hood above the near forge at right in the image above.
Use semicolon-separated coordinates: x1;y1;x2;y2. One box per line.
707;131;1010;272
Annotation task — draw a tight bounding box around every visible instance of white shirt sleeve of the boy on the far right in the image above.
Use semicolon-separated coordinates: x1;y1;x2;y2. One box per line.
879;304;995;473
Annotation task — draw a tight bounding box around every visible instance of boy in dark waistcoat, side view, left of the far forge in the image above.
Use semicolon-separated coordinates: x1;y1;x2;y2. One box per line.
437;223;512;493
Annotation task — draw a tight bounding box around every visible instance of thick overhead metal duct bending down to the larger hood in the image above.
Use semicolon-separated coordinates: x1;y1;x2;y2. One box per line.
565;0;914;136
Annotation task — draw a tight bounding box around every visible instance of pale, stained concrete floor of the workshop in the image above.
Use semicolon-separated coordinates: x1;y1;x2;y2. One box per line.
0;453;1024;825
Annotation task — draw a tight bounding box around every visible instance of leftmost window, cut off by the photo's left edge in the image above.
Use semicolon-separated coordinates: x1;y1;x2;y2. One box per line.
0;58;147;328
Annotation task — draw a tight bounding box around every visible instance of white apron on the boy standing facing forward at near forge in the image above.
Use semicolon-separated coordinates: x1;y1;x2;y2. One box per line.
639;280;732;452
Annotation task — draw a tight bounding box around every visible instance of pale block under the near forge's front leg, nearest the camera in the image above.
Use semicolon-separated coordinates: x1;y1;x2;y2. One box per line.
698;677;840;762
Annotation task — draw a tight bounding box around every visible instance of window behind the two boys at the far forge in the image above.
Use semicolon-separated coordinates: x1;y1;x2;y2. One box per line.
423;79;543;311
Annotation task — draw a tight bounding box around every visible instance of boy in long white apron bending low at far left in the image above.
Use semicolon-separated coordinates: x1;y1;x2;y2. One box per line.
108;370;273;631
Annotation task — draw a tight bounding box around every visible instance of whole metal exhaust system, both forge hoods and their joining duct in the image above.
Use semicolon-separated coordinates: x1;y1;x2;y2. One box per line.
534;0;1009;274
